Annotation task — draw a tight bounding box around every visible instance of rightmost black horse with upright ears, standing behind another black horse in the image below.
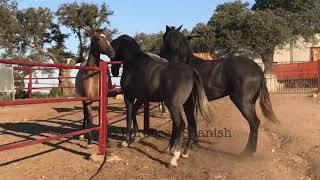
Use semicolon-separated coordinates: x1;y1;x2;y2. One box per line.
160;26;278;154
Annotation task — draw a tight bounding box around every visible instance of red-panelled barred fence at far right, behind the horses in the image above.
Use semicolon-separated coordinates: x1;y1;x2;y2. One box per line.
258;61;320;94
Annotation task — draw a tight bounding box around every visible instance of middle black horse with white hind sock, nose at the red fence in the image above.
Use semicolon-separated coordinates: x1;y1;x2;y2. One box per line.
111;35;212;166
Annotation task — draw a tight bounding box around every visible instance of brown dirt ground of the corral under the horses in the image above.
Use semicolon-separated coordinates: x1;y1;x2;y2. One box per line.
0;95;320;180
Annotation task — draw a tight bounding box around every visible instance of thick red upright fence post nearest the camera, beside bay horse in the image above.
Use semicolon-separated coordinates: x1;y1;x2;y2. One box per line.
99;61;108;155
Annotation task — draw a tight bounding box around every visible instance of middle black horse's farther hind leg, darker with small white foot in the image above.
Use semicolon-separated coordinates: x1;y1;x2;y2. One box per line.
181;98;198;158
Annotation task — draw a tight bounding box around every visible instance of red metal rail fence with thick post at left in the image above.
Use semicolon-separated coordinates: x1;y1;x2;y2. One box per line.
0;59;153;154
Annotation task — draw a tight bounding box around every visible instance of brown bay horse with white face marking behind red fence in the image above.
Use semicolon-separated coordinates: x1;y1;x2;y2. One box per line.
76;30;115;146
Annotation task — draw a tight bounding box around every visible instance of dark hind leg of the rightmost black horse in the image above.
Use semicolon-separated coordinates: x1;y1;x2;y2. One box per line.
230;96;260;155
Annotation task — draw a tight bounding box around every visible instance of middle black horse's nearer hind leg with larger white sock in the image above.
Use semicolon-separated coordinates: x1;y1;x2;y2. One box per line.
170;106;186;166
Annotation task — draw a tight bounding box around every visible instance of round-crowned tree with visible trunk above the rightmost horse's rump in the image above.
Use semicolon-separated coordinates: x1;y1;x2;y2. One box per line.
244;11;291;74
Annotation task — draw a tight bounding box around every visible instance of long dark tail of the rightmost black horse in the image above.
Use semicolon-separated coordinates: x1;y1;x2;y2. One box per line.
260;75;279;123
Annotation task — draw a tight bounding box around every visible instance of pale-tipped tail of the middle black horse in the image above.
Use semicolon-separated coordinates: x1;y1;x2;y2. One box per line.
192;70;215;125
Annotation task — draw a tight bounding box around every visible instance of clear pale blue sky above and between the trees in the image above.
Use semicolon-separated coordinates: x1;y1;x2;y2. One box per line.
18;0;254;90
